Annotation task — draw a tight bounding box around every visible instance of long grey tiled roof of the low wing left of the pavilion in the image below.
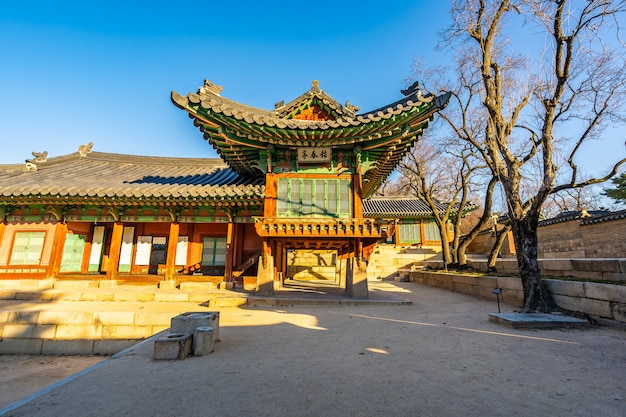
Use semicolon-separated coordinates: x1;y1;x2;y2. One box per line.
0;152;265;203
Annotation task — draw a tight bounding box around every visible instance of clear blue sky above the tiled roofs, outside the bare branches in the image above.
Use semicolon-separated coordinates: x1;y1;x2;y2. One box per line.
0;0;626;179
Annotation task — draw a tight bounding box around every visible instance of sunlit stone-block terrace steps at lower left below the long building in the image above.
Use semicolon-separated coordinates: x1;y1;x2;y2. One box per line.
0;279;247;355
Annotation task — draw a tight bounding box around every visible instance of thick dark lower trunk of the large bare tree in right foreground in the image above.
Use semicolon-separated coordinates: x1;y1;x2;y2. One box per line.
511;218;558;313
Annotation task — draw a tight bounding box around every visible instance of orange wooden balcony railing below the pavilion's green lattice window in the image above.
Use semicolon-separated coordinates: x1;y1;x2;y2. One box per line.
254;217;395;239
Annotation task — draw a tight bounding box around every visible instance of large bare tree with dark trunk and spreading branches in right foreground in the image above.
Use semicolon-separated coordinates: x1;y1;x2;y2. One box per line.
436;0;626;312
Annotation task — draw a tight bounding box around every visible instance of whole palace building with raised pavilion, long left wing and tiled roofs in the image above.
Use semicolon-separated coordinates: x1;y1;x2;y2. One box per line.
0;81;449;297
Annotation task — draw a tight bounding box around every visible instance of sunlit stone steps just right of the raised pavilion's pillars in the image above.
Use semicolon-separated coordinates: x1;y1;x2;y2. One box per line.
367;245;441;281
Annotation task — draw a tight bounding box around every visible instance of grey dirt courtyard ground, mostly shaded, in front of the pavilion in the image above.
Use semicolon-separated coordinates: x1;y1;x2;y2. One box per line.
0;283;626;417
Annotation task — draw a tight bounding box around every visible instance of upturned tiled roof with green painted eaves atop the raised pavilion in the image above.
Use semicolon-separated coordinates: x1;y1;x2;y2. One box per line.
171;81;450;196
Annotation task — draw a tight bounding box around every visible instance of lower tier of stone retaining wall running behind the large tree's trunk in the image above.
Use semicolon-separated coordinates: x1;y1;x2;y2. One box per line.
410;271;626;323
